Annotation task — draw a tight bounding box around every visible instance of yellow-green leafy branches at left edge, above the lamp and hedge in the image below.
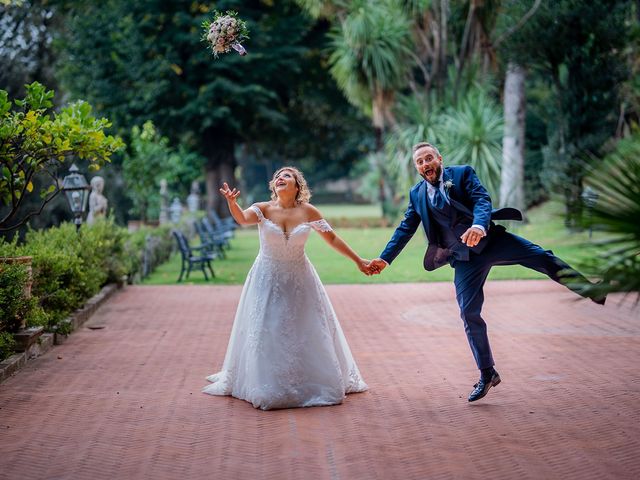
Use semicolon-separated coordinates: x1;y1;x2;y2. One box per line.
0;82;123;232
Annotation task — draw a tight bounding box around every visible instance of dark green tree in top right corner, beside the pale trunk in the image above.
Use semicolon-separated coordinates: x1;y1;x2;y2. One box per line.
499;0;633;227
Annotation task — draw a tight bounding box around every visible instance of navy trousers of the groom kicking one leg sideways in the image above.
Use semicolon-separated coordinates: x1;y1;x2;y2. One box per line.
453;231;588;369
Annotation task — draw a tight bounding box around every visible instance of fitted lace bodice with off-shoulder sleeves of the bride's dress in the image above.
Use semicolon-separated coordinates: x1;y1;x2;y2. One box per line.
251;205;332;261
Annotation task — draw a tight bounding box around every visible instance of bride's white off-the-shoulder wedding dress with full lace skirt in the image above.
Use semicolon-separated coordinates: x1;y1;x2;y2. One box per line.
202;205;367;410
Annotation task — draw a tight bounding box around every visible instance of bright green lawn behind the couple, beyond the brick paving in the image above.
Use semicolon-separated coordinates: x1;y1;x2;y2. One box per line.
144;203;597;285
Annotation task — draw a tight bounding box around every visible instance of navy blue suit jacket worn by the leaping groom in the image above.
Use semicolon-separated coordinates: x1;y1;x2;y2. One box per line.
380;165;522;271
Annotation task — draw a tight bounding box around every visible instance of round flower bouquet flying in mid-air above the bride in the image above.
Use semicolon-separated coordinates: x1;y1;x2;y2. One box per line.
202;10;249;58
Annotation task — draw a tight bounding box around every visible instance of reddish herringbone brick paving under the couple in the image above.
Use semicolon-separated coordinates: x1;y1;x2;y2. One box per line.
0;281;640;480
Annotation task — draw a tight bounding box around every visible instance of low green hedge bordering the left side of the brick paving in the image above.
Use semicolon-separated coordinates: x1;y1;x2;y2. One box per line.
0;214;172;333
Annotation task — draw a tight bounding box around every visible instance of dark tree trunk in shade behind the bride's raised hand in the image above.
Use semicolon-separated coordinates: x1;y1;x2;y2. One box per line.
204;130;236;217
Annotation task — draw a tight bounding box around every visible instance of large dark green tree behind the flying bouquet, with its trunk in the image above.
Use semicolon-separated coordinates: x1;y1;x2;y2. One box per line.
55;0;322;214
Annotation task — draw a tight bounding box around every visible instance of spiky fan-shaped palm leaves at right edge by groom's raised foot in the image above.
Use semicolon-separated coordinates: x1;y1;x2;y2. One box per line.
587;131;640;300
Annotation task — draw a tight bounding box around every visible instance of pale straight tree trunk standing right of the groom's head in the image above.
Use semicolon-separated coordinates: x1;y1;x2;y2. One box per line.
500;62;526;218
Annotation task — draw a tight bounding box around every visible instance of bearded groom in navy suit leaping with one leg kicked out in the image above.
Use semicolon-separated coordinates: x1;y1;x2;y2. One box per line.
369;143;605;402
